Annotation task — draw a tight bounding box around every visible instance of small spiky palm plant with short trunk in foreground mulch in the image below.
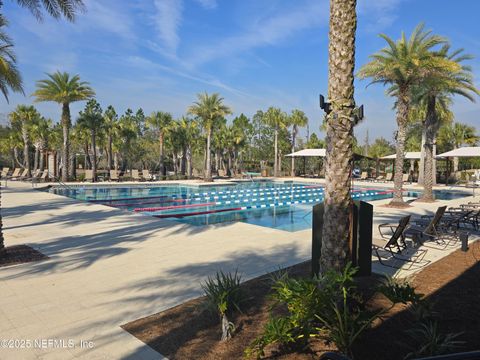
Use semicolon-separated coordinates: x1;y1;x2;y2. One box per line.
202;270;244;341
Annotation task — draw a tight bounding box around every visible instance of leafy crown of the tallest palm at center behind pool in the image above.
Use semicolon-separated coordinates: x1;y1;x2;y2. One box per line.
188;93;232;130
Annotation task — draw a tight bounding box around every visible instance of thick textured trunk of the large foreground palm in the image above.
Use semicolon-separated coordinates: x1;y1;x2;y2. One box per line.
320;0;357;272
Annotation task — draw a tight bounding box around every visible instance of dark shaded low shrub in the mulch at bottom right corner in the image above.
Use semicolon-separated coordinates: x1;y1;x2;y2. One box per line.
405;320;464;359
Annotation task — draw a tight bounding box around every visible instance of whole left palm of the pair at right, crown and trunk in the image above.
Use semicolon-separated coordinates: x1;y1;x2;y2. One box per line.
358;24;445;206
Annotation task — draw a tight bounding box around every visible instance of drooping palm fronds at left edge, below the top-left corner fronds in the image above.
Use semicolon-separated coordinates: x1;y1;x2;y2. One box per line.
0;15;24;102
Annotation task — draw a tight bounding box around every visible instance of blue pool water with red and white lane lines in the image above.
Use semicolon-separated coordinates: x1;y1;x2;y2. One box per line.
50;181;466;231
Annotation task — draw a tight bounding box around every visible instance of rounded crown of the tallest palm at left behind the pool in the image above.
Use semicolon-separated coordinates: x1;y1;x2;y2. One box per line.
32;71;95;104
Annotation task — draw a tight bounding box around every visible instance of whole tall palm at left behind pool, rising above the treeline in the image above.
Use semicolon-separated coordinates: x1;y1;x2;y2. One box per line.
33;71;95;182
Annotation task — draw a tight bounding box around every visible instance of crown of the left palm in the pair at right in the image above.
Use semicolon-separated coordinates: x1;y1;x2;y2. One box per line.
357;24;446;91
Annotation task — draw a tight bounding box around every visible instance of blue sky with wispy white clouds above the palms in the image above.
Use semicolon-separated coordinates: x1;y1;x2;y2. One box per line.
0;0;480;141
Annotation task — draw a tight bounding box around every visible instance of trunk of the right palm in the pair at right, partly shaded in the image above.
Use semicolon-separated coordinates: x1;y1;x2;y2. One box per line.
422;97;436;201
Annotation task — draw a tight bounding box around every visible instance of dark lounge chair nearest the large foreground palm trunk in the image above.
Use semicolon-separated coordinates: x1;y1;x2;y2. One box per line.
372;215;429;270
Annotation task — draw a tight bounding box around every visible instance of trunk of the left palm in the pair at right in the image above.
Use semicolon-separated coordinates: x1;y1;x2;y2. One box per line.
390;88;409;206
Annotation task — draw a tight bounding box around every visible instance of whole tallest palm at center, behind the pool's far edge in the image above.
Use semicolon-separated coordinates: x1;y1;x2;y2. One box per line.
188;93;232;182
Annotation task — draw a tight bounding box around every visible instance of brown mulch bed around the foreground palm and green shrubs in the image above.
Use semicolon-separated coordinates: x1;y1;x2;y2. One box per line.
122;241;480;360
